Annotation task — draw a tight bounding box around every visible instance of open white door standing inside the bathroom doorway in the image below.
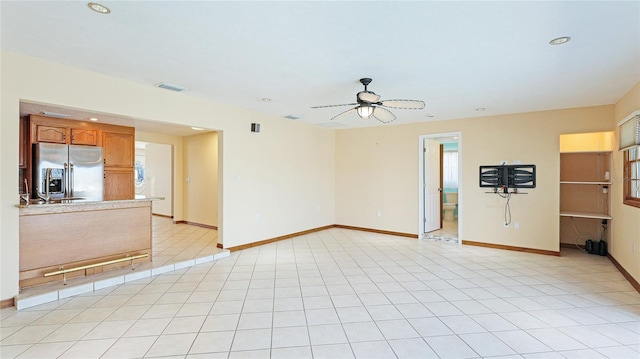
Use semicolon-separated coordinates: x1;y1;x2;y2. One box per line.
424;139;442;233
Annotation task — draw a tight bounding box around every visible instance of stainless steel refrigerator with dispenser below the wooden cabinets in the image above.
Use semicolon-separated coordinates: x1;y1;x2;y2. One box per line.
32;143;104;201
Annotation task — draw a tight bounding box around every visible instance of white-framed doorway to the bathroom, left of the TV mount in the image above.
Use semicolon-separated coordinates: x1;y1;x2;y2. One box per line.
418;132;463;243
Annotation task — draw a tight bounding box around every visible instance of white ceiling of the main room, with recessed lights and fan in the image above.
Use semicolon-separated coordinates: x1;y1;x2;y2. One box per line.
0;0;640;133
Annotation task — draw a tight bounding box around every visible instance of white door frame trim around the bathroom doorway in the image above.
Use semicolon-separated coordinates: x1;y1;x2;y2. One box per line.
418;131;464;240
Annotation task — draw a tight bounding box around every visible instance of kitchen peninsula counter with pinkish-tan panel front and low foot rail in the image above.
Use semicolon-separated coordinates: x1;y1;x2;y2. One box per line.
18;197;163;288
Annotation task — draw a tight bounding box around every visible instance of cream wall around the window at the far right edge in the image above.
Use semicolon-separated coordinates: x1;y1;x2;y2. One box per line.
609;82;640;282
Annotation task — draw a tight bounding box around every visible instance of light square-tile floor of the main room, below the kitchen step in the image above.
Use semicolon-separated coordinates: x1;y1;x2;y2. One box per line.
0;224;640;359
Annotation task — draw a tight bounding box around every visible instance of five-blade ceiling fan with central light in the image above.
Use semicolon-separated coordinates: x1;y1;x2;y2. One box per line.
311;77;424;123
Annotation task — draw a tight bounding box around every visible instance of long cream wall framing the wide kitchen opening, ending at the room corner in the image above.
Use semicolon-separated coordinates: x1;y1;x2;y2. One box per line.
0;51;335;300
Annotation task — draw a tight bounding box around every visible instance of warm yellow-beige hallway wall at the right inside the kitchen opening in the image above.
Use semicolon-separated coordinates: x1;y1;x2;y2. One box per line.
182;132;218;227
